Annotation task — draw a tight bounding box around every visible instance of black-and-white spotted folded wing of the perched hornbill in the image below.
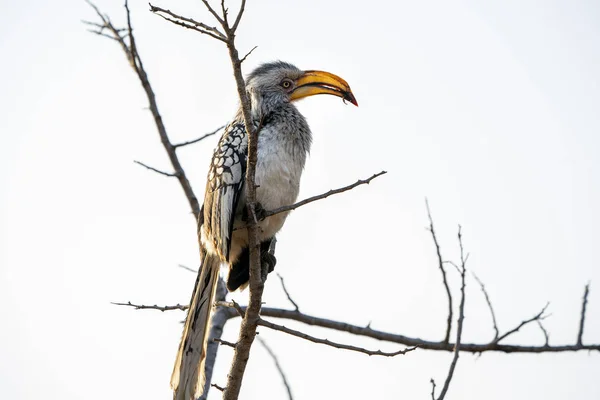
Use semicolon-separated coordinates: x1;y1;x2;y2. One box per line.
204;122;248;261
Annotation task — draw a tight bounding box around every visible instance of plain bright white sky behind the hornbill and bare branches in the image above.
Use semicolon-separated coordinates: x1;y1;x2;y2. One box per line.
0;0;600;400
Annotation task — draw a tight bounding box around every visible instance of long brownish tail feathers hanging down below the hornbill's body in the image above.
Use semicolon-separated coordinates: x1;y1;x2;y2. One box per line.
171;254;220;400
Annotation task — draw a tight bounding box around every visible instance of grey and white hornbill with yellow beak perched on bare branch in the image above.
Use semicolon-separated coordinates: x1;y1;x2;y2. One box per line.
171;61;358;400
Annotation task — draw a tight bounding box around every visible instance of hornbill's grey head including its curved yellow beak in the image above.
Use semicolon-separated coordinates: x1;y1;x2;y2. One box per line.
246;61;358;114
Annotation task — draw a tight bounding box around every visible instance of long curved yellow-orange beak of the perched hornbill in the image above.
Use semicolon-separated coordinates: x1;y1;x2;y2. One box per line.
290;71;358;107
